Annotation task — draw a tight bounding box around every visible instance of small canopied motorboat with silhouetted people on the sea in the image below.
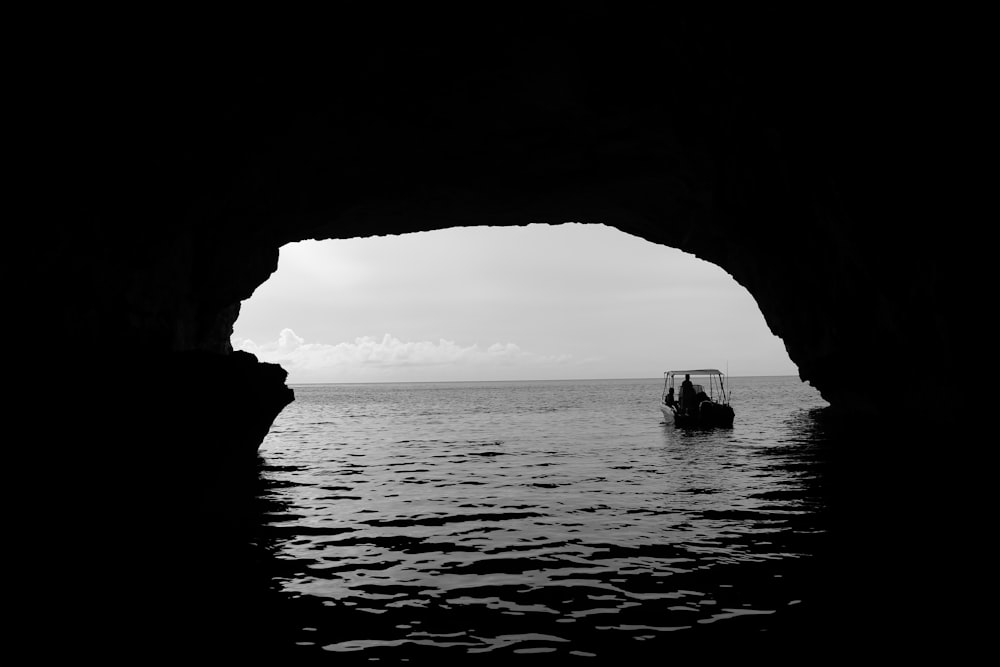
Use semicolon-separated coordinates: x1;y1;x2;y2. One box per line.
660;368;736;428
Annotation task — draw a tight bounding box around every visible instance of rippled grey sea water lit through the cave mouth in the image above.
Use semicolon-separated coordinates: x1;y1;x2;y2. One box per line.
236;377;860;660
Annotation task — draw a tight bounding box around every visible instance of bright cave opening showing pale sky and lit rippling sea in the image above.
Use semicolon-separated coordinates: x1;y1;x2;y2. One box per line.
213;223;844;655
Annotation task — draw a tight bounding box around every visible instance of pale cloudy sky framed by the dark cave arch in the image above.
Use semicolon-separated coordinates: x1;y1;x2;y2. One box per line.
232;223;798;384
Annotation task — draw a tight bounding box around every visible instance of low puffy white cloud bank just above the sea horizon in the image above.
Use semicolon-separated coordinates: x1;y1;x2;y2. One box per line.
232;328;573;382
